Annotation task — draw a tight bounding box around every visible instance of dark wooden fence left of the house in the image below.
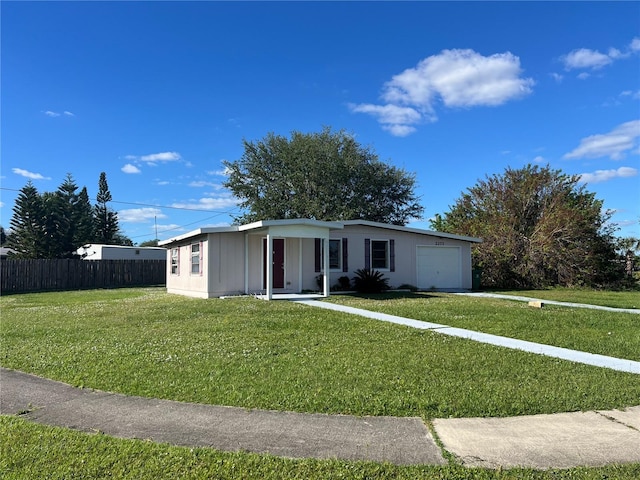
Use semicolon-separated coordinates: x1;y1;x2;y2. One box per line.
0;259;167;294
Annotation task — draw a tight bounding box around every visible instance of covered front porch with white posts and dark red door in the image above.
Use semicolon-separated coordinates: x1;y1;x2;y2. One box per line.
238;219;343;300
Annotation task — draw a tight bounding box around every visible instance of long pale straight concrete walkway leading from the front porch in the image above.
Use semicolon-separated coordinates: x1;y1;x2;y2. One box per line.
294;295;640;374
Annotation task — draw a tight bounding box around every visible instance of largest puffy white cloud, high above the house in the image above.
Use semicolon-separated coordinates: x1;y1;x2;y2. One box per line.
348;49;534;136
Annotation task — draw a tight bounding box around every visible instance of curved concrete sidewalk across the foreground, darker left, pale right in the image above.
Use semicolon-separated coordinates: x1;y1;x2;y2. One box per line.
0;369;640;469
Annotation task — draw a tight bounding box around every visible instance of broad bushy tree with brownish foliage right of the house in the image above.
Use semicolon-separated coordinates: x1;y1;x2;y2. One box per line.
432;165;620;287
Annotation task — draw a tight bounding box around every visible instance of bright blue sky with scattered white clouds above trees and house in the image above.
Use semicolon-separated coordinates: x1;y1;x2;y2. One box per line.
0;1;640;243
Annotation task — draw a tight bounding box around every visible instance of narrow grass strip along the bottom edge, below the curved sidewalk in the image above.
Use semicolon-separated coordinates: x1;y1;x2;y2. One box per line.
0;416;640;480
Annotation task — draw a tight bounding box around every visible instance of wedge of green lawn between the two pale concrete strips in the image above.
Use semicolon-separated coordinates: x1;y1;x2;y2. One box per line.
329;293;640;362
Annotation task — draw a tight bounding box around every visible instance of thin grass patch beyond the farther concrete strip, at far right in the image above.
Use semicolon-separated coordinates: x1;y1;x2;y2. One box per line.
496;287;640;308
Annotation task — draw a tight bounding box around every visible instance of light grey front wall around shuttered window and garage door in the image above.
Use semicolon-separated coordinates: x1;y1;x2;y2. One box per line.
328;225;471;289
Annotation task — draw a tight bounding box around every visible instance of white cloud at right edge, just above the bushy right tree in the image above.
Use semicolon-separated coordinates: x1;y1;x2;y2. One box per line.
563;120;640;160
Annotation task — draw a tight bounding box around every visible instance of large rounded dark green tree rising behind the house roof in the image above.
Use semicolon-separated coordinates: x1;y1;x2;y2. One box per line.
224;127;424;225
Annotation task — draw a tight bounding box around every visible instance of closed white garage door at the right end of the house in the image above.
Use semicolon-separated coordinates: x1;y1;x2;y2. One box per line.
416;246;462;289
